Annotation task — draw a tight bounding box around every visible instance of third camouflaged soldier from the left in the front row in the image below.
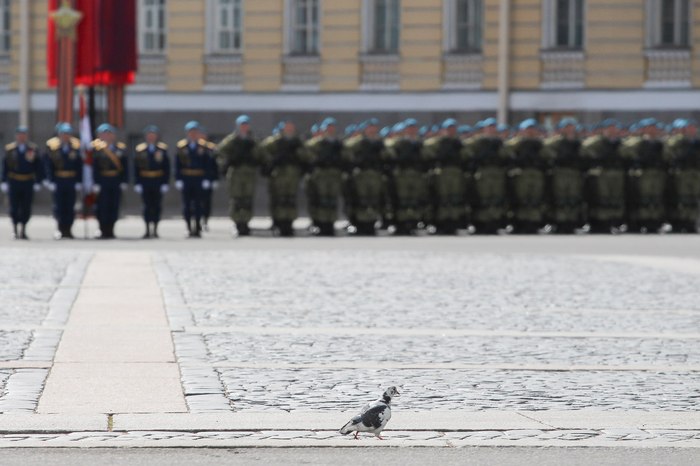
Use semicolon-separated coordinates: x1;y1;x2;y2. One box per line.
306;118;344;236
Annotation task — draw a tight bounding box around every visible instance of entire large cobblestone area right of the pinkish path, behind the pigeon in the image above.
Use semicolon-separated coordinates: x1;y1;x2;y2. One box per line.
163;250;700;412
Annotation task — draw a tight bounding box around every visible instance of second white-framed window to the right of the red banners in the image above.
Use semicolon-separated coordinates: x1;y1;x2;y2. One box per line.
209;0;243;54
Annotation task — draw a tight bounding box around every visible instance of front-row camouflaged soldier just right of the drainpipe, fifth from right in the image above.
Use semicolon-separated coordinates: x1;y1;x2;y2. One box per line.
506;118;547;233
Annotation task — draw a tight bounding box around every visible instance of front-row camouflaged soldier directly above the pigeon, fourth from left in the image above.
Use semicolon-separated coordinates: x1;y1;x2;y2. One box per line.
344;119;387;235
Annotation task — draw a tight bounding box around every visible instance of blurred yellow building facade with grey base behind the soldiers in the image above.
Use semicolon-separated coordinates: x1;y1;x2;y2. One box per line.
0;0;700;143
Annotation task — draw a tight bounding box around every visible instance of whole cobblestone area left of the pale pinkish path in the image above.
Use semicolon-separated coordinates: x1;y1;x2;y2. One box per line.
0;248;91;413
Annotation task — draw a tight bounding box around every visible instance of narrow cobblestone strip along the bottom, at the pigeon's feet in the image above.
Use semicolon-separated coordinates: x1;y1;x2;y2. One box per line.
0;429;700;448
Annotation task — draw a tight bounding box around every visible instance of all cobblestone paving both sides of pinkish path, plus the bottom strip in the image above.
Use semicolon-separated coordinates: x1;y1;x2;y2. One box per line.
0;233;700;447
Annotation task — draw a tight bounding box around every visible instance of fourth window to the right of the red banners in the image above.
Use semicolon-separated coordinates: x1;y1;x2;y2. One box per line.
364;0;401;54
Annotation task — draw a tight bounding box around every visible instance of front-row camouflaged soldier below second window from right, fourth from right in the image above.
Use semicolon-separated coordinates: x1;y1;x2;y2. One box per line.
544;118;584;233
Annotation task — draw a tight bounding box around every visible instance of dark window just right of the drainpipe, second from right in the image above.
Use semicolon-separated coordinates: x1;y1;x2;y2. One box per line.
543;0;584;50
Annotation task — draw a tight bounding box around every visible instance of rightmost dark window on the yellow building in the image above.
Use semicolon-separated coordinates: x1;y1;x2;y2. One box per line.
647;0;690;48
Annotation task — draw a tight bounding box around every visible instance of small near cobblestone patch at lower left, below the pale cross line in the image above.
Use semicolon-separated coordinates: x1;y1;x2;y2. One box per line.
0;369;49;414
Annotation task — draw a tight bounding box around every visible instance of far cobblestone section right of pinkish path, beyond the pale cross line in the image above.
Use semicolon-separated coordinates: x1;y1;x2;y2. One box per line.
167;251;700;332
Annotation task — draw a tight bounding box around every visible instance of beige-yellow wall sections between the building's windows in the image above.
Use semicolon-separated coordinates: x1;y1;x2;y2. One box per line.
5;0;700;92
